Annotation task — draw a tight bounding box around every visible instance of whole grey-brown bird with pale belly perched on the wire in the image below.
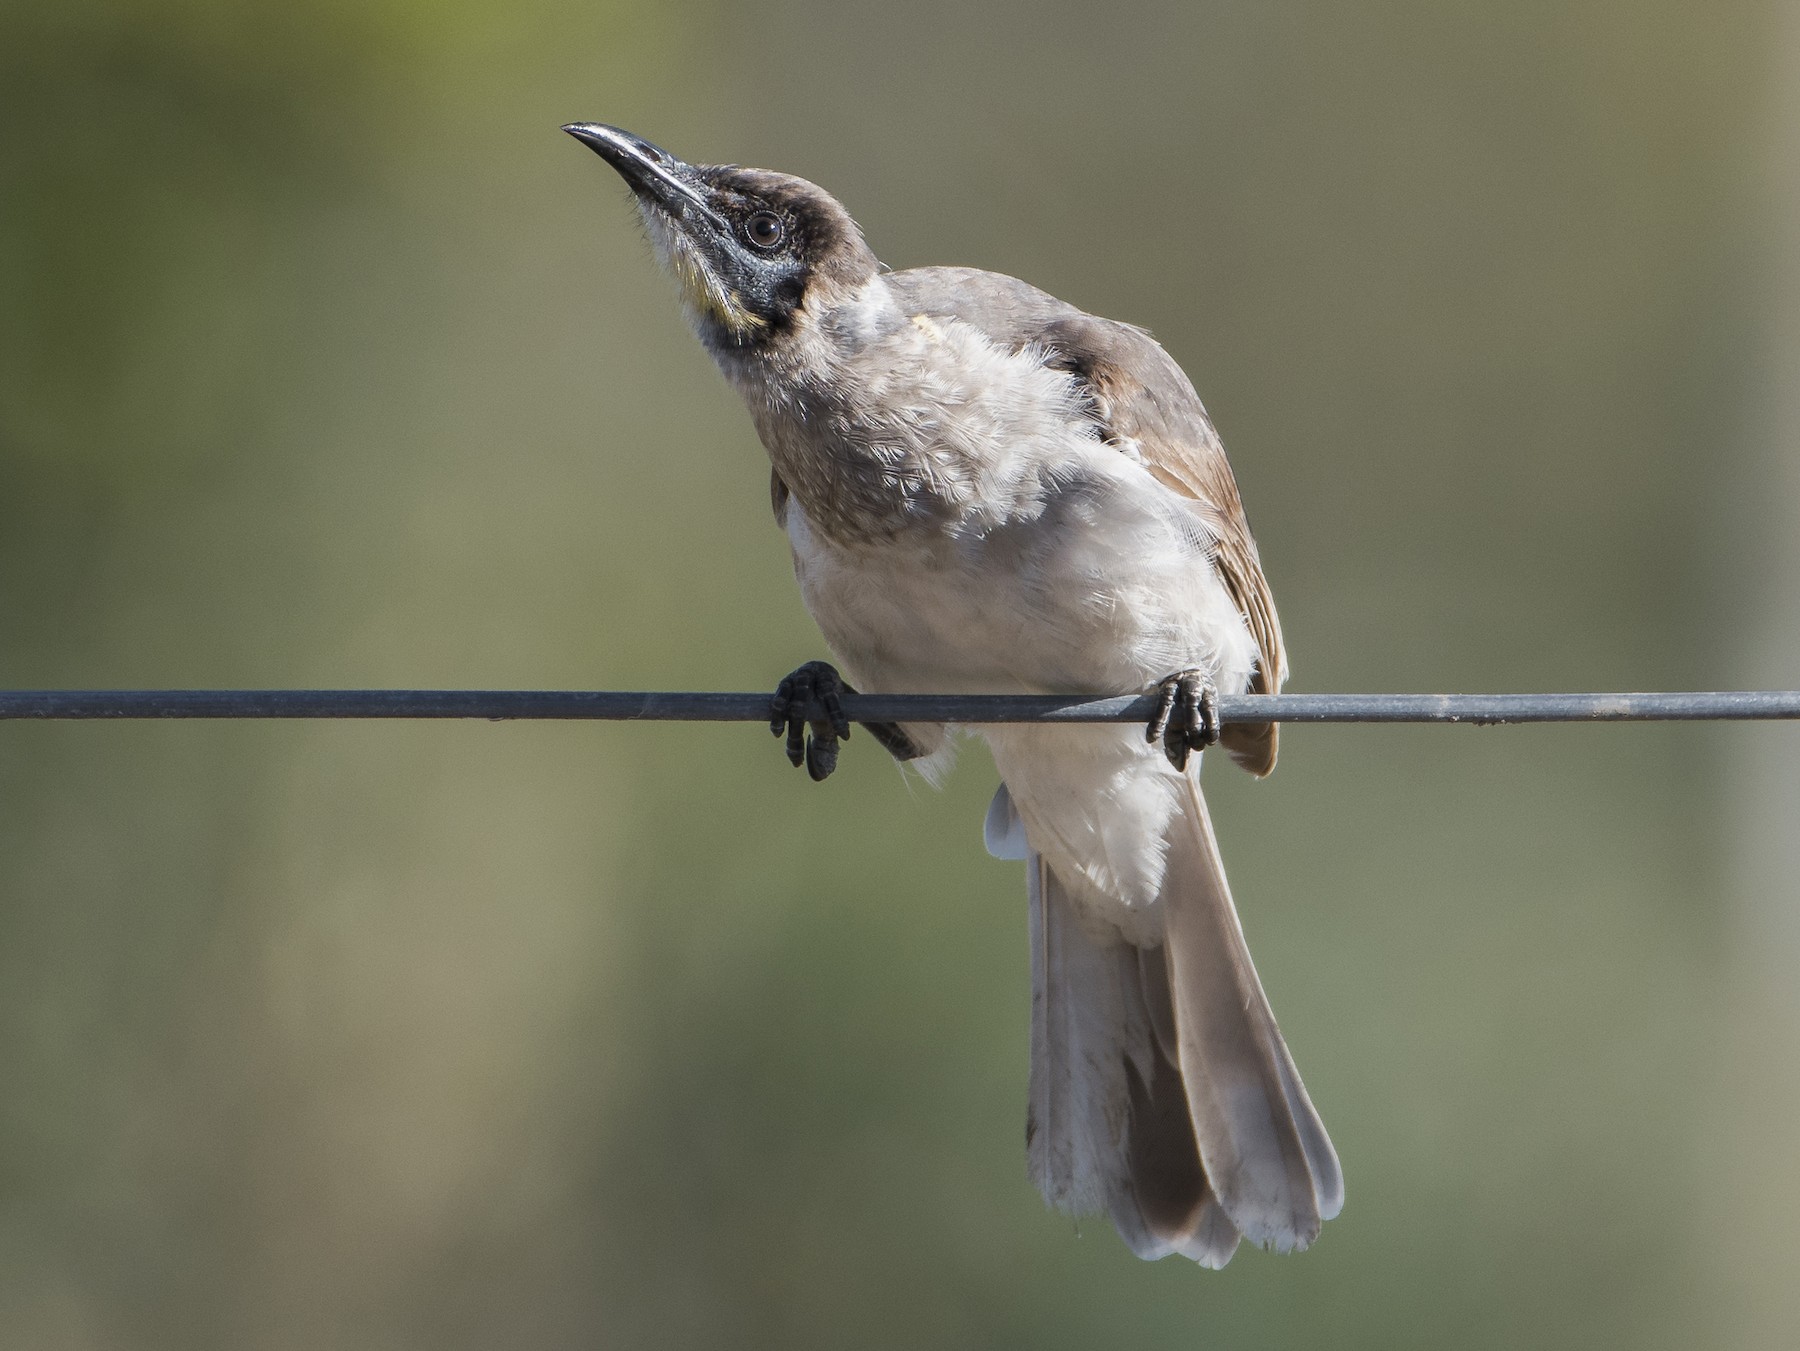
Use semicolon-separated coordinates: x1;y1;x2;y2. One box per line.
563;122;1343;1268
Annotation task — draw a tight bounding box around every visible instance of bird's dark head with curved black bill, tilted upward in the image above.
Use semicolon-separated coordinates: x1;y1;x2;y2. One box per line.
563;122;880;349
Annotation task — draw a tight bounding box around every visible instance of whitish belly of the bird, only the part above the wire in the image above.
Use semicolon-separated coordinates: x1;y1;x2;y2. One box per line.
787;448;1256;694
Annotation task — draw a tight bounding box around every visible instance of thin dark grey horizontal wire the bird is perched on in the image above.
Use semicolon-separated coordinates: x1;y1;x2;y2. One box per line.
0;689;1800;725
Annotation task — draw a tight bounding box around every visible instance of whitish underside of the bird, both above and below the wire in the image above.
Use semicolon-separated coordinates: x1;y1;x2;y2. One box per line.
787;452;1255;943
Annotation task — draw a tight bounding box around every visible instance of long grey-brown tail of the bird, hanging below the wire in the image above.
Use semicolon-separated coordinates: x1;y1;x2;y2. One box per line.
1015;779;1343;1266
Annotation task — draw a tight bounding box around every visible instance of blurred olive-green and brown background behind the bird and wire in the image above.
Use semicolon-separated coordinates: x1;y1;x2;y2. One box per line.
0;0;1800;1349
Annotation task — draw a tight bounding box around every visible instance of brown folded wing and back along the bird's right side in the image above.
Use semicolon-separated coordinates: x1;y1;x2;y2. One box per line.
886;268;1287;775
